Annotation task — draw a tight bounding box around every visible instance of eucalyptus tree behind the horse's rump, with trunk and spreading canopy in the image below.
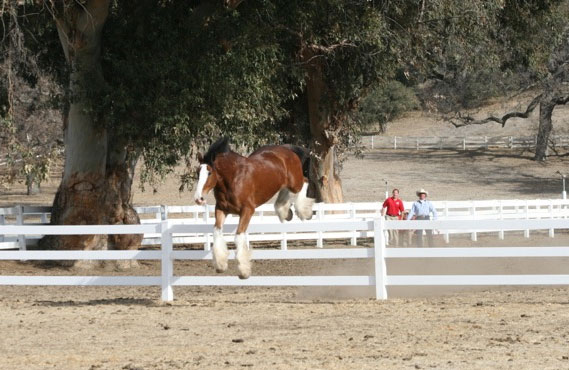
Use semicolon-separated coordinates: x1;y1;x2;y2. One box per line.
258;0;510;202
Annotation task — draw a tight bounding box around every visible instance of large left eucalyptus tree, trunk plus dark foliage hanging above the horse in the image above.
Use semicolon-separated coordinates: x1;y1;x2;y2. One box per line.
13;0;286;249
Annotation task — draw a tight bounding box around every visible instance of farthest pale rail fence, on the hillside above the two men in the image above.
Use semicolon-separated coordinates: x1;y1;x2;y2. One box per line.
362;135;569;150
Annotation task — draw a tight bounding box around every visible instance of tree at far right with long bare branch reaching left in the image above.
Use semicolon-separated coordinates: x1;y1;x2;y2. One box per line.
442;0;569;161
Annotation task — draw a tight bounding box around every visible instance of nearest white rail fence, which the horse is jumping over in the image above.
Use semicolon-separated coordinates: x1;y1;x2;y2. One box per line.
0;218;569;301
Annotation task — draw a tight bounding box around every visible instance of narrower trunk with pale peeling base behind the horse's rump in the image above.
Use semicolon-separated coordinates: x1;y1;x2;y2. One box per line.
302;49;344;203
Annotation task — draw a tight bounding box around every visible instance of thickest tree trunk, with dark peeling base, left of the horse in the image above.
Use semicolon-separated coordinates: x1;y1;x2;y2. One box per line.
40;0;141;254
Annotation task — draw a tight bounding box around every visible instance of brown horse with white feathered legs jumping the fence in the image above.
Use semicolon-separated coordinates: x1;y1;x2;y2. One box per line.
194;138;314;279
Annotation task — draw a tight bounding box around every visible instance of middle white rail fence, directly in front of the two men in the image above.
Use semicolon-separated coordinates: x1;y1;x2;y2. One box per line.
0;199;569;250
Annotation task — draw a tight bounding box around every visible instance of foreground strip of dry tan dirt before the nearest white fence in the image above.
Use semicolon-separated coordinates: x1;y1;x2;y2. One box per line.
0;287;569;369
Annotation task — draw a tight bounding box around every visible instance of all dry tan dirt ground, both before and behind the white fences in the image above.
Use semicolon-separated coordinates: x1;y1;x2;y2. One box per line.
0;110;569;370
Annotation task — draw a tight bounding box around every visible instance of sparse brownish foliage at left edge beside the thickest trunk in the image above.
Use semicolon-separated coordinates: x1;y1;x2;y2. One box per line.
0;0;62;195
